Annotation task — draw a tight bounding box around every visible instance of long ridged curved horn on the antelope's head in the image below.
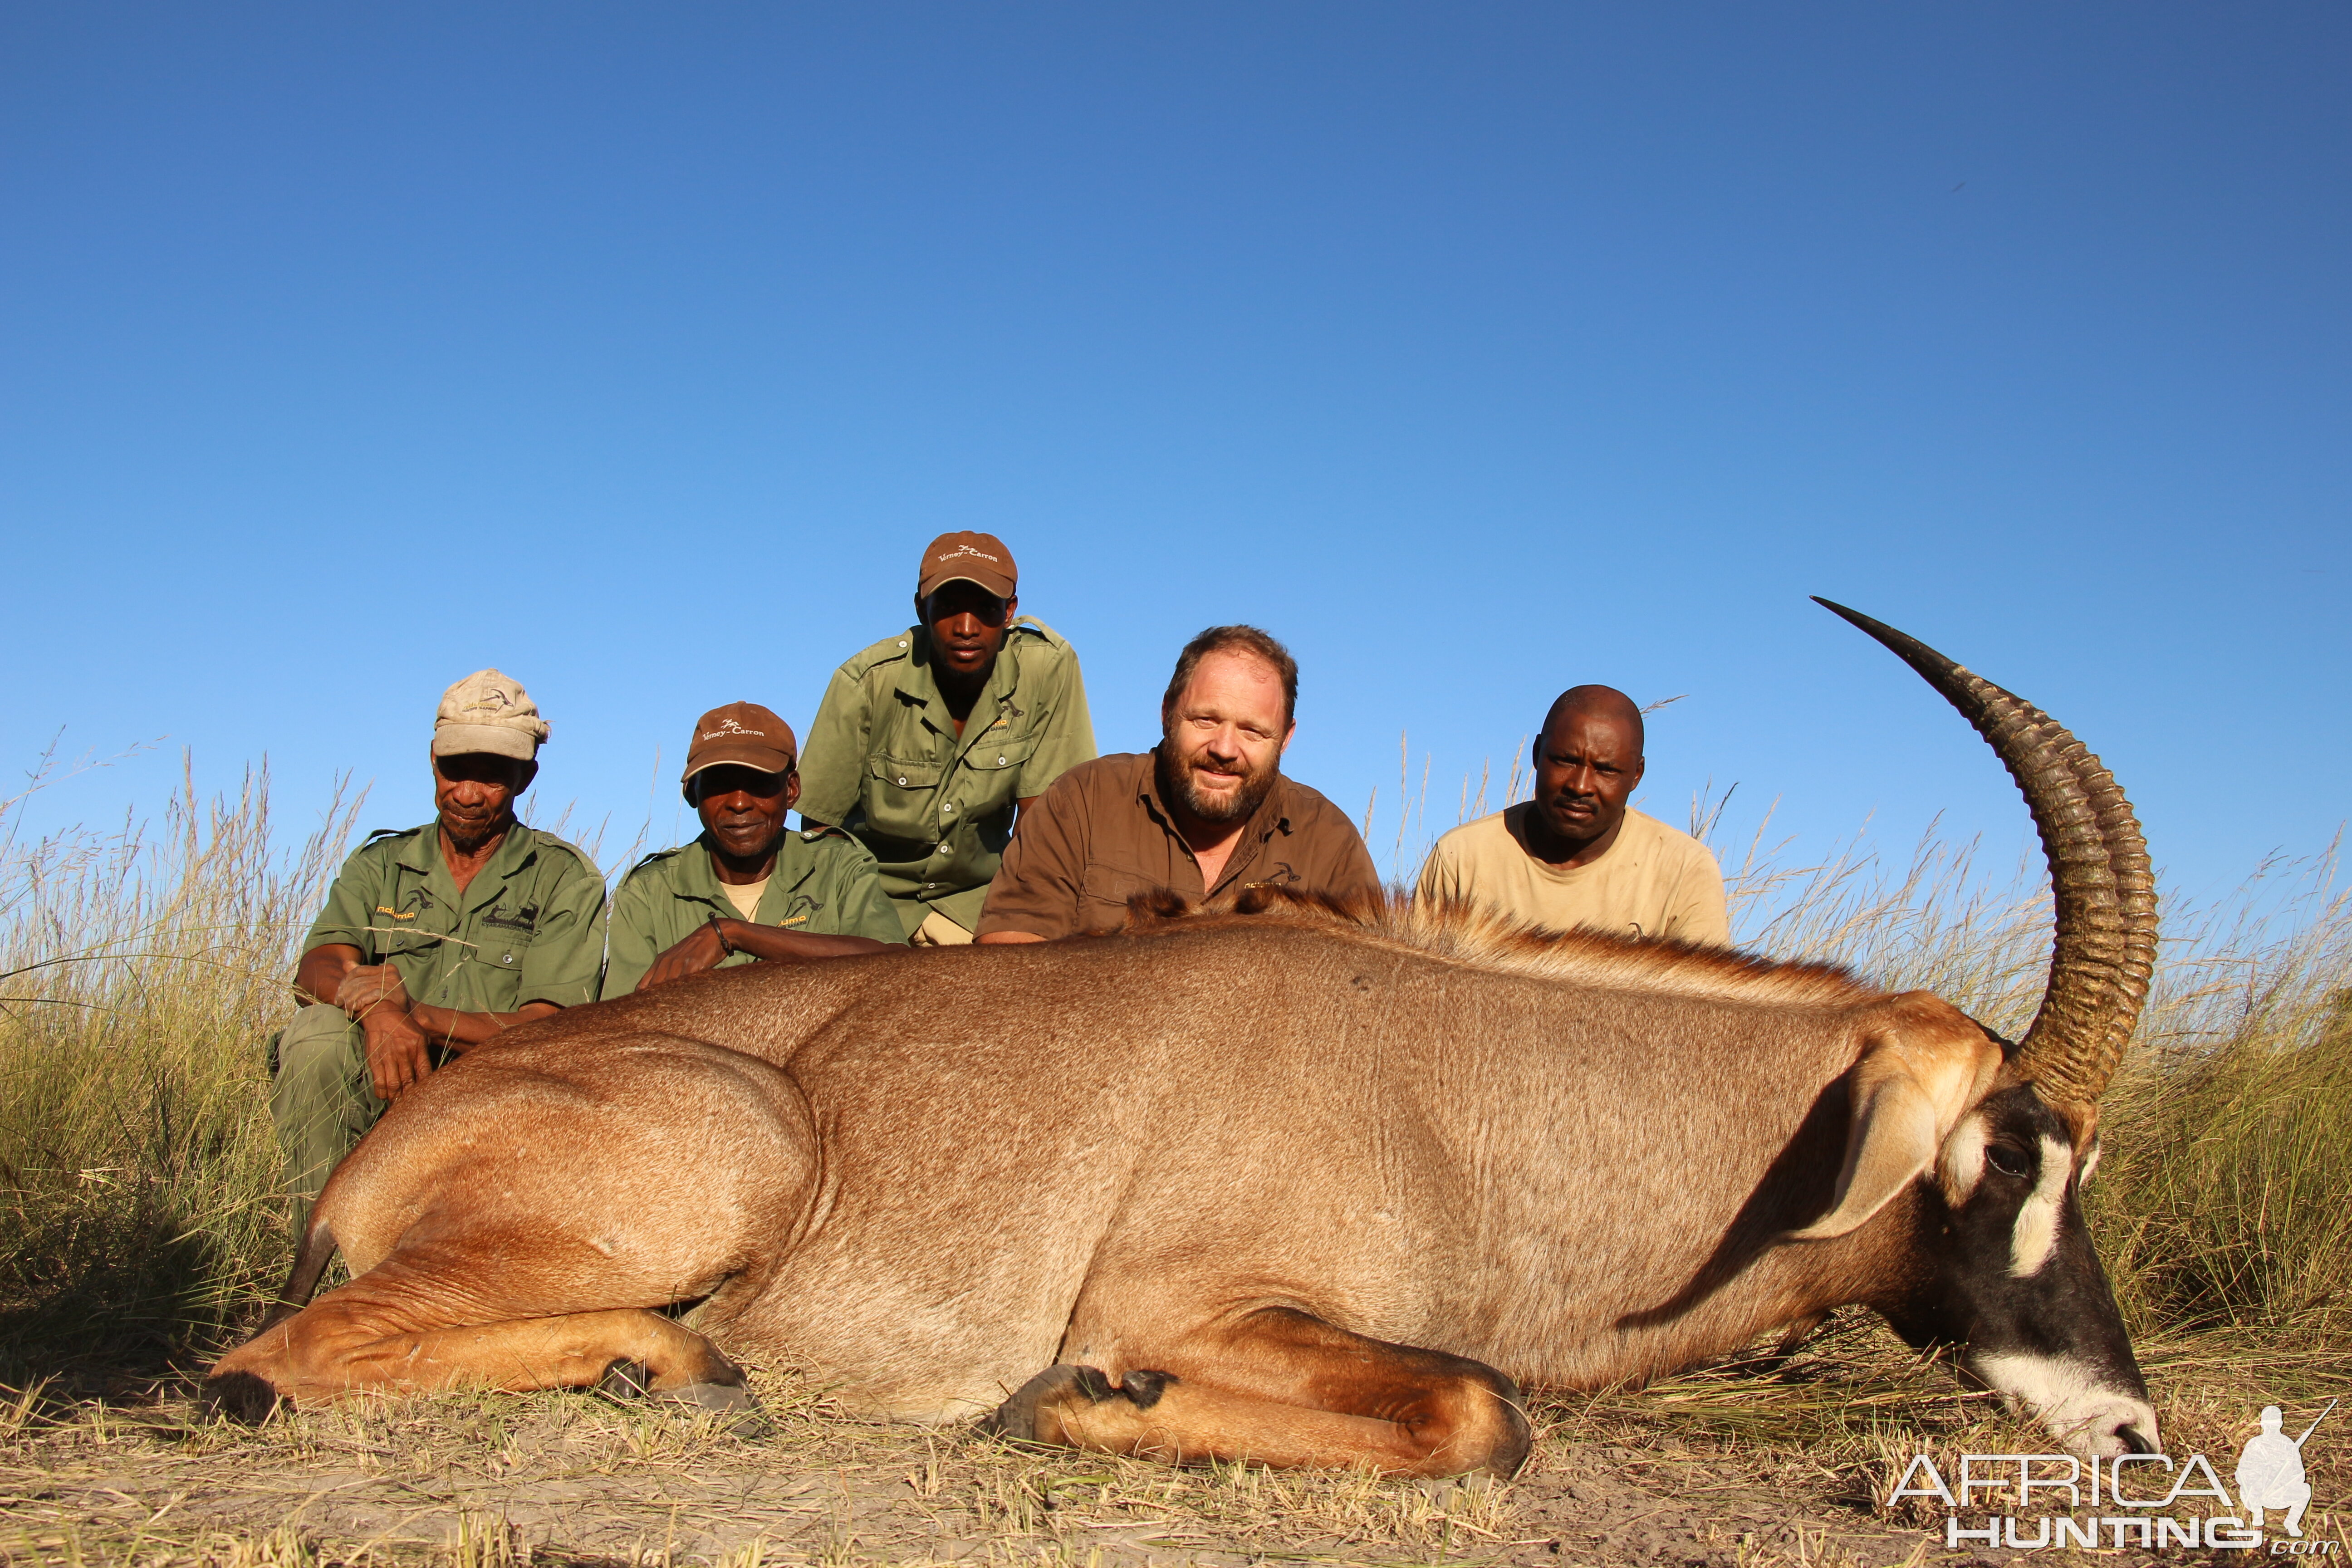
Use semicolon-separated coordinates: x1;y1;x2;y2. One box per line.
1813;595;2157;1105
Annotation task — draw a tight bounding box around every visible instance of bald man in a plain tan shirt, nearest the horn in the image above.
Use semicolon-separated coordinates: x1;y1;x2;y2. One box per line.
1414;686;1731;947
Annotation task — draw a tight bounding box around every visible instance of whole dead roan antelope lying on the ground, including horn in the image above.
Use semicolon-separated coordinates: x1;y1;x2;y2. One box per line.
209;607;2157;1474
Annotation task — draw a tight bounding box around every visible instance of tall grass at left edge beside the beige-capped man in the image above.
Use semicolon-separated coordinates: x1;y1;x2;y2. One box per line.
0;771;353;1382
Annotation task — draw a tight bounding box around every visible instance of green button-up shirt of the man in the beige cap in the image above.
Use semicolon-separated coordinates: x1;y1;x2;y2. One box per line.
304;823;604;1013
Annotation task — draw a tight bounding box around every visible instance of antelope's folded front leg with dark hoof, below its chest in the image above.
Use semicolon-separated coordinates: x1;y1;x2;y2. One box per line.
993;1307;1534;1476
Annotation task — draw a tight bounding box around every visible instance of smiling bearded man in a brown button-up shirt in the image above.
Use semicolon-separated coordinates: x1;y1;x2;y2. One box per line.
979;625;1381;943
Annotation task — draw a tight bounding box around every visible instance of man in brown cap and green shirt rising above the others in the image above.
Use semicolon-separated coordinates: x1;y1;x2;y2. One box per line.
800;534;1094;945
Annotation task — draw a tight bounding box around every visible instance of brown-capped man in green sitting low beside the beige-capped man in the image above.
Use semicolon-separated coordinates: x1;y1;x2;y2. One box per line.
604;703;906;997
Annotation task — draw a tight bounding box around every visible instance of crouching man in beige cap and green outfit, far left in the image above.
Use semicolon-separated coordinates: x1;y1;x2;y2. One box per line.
270;670;604;1222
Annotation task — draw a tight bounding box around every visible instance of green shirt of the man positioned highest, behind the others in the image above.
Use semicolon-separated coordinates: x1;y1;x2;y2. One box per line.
800;616;1094;933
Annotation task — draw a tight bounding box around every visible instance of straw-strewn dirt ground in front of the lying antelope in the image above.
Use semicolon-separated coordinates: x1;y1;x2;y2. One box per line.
0;1319;2352;1568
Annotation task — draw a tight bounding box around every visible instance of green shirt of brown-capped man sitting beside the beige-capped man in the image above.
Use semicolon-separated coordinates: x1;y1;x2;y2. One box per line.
604;828;906;997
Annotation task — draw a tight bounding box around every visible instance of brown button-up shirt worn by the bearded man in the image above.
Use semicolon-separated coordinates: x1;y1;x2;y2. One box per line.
981;752;1381;936
